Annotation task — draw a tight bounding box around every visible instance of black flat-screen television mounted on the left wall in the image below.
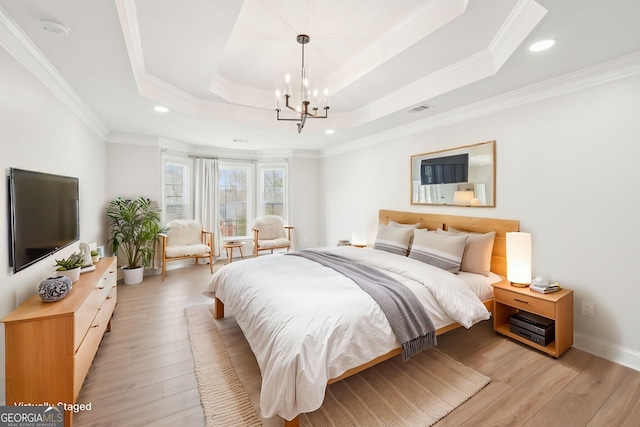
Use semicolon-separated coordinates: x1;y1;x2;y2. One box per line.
8;168;80;273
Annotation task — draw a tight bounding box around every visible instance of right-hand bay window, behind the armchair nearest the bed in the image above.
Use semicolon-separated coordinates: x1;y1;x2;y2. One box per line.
258;164;287;219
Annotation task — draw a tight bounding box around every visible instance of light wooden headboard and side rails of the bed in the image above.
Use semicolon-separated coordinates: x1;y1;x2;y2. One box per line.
214;210;520;427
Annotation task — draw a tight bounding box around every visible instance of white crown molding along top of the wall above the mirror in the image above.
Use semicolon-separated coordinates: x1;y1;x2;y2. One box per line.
320;52;640;158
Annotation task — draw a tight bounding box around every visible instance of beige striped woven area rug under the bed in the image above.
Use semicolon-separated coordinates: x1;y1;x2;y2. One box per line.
185;306;490;427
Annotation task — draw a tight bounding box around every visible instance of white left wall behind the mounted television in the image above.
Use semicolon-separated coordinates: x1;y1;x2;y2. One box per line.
0;49;106;401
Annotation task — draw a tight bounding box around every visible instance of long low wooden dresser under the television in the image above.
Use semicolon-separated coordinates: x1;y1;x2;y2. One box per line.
2;257;117;426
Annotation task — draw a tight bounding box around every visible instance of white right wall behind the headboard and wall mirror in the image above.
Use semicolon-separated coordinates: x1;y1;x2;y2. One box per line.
321;76;640;370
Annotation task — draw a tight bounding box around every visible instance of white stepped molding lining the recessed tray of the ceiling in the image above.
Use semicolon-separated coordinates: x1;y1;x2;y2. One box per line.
116;0;546;132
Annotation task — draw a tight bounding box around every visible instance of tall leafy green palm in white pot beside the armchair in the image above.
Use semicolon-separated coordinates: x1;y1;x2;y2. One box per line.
107;197;164;285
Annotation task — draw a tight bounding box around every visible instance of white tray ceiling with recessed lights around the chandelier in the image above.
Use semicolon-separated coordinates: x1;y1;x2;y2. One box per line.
0;0;640;151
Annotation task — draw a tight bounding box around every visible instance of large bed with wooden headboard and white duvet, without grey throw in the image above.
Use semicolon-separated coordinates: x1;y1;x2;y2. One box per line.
208;210;519;426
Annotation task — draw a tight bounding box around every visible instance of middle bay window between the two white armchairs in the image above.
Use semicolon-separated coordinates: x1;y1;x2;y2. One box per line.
218;164;252;239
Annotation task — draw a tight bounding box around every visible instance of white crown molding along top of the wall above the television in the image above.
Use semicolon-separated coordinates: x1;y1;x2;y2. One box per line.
0;6;109;139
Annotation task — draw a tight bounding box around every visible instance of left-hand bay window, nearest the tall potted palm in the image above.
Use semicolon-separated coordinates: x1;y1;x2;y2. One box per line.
162;156;193;223
